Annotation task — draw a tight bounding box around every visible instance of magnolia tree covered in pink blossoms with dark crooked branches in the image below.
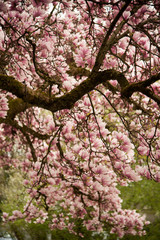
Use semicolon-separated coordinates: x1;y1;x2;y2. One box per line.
0;0;160;237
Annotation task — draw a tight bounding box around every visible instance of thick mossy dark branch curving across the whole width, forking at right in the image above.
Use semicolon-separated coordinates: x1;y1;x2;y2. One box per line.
0;69;160;112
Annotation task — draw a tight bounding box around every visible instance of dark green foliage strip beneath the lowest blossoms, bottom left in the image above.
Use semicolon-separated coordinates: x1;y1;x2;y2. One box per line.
0;219;104;240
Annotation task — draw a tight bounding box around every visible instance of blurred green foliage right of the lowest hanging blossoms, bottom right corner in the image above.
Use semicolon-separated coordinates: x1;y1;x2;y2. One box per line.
119;179;160;240
